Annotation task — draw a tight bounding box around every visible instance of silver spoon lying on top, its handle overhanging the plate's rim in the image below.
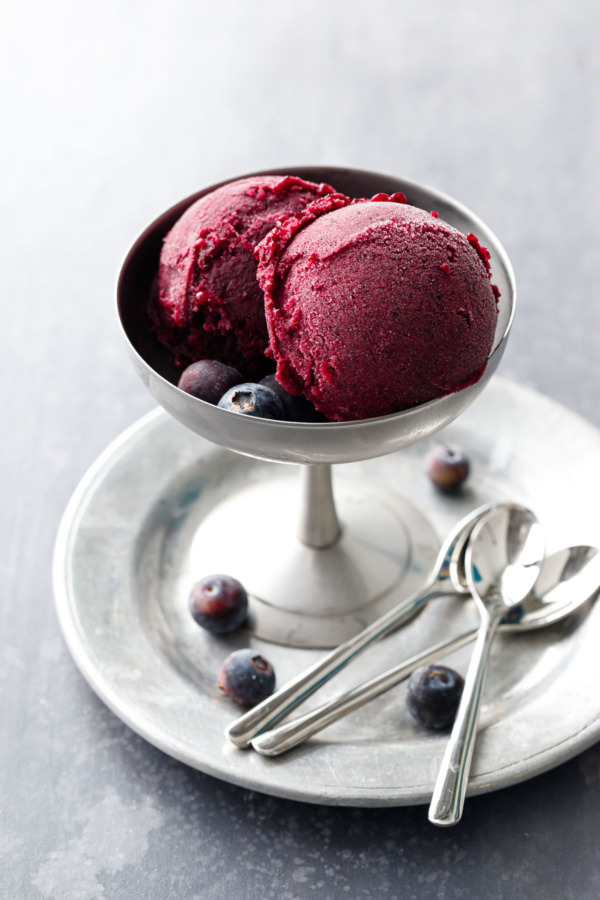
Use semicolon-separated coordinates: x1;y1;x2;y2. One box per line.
429;509;544;826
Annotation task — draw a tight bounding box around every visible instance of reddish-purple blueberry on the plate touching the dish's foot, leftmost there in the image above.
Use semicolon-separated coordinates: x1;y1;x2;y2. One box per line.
189;575;248;634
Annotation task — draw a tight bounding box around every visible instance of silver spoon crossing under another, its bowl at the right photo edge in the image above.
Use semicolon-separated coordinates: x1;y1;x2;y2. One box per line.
252;546;600;756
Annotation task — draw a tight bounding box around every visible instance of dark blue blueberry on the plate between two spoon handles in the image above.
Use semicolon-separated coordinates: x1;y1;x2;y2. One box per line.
406;666;465;729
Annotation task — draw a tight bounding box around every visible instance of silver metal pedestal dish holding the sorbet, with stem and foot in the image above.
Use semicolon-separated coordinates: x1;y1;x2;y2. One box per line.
118;168;515;647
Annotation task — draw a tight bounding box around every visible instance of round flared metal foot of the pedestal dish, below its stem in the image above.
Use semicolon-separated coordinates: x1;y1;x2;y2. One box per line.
189;478;439;648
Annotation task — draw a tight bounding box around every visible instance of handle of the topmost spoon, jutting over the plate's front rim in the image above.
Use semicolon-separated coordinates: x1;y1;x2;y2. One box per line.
429;613;502;826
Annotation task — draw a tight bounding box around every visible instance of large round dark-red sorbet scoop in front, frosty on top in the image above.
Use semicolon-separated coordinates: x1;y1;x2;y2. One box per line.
256;194;498;421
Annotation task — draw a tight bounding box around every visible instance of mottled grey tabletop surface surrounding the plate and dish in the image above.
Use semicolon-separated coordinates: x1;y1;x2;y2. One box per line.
0;0;600;900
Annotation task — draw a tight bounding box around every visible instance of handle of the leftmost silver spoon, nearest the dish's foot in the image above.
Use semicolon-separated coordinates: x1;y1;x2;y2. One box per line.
225;579;440;747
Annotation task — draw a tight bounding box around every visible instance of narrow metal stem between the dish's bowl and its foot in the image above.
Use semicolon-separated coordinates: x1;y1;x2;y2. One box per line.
298;463;341;550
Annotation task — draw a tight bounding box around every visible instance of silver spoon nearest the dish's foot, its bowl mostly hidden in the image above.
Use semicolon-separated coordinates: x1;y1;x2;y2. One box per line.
225;504;510;747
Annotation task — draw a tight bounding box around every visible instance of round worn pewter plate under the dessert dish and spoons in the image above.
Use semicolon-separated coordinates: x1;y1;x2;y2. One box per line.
54;378;600;806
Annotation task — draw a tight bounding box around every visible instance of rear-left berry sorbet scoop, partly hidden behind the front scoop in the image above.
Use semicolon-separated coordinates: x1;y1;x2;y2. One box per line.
151;175;340;379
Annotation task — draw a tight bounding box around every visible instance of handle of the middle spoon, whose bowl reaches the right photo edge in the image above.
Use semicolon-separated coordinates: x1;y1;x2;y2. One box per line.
252;631;477;756
